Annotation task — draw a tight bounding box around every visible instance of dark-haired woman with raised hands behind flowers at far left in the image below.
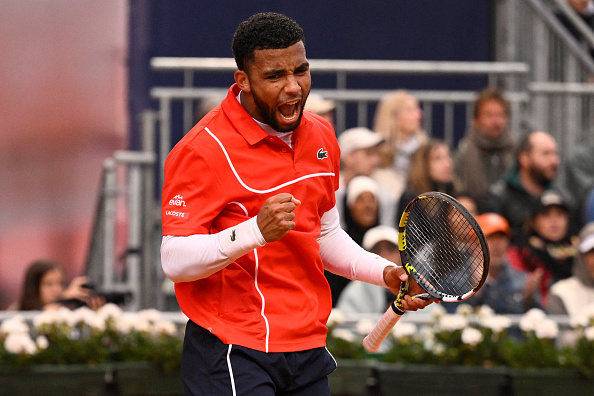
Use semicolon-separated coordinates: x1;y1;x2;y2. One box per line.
10;260;105;311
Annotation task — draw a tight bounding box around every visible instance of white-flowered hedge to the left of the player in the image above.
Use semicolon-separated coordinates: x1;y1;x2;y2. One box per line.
0;304;182;371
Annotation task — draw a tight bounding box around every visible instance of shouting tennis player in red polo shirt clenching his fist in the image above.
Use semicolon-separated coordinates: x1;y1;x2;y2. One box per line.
161;13;429;396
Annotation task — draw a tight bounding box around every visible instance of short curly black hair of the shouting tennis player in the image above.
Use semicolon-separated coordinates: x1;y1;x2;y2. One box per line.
233;12;305;71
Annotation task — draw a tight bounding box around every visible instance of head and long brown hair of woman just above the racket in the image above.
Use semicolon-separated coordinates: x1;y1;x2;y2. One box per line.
396;139;455;220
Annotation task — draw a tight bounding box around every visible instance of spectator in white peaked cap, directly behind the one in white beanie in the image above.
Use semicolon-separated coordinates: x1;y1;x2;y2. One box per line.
336;127;397;228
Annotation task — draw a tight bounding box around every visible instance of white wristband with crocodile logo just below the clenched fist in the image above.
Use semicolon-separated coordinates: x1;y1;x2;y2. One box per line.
218;217;266;260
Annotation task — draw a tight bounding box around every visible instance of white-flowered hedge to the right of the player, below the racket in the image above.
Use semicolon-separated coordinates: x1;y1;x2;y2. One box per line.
328;304;594;376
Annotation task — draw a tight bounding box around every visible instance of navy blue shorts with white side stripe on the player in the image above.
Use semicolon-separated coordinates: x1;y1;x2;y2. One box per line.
181;321;336;396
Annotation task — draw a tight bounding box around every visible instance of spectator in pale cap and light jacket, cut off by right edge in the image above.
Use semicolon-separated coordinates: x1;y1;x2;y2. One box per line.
547;222;594;317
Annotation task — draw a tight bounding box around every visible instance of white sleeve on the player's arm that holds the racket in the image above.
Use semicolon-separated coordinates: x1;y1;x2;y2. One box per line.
318;206;396;287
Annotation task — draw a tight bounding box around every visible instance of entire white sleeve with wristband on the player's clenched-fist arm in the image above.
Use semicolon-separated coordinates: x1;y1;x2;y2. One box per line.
161;217;266;282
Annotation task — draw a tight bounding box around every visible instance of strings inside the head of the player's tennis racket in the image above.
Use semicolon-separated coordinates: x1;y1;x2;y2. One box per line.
406;198;484;296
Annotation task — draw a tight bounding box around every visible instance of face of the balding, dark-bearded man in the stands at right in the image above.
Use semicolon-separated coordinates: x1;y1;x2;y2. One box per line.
523;133;559;186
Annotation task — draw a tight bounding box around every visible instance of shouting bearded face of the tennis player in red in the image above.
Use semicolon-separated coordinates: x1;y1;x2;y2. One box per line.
235;41;311;132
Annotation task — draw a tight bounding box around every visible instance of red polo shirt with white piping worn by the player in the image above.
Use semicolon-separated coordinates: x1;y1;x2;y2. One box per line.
162;85;340;352
